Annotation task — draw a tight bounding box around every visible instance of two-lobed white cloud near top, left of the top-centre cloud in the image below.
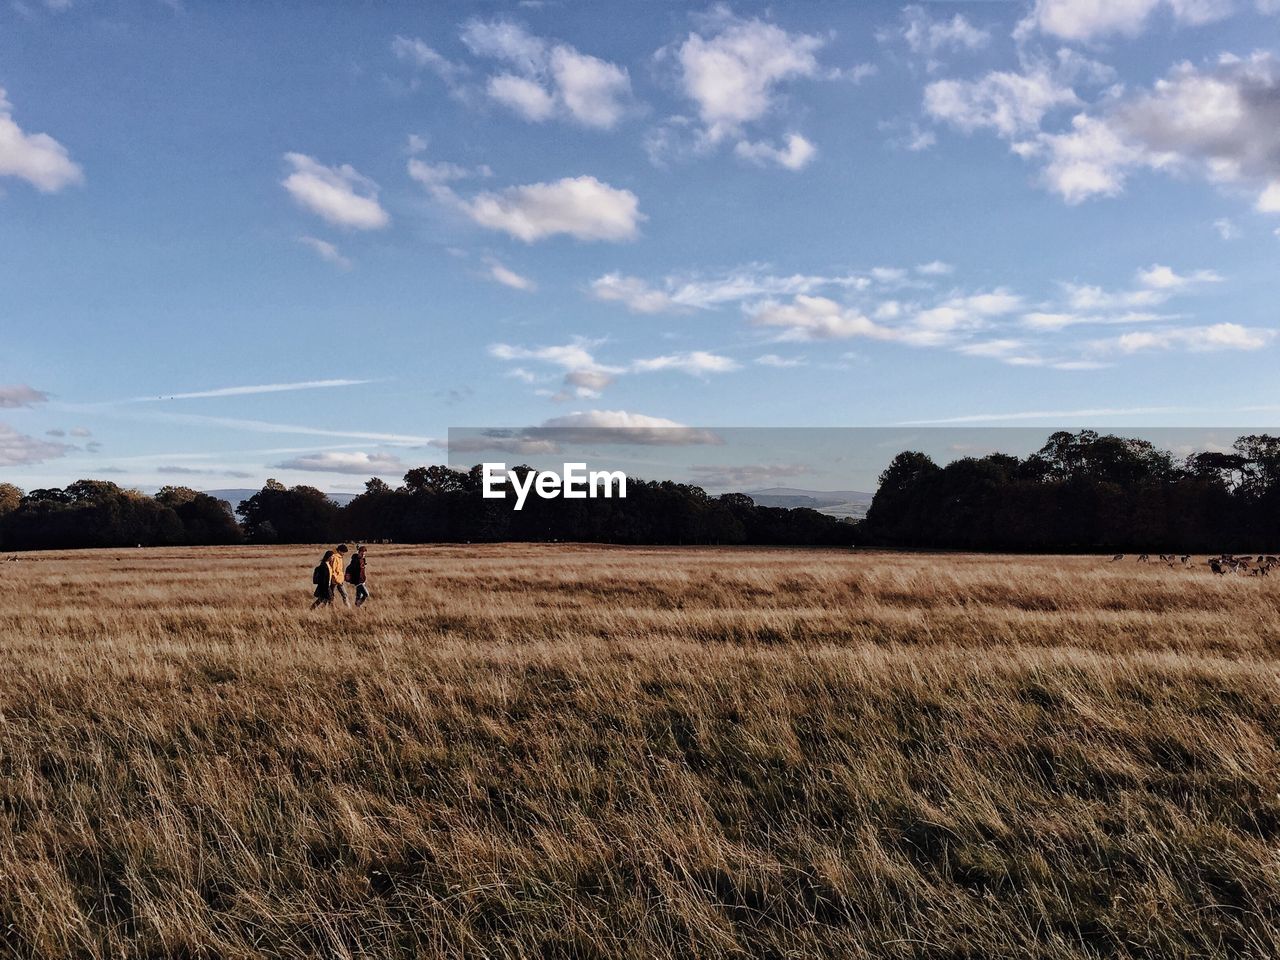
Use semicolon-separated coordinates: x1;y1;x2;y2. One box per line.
462;20;631;129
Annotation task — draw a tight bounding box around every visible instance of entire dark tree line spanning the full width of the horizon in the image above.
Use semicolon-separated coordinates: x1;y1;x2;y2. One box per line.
0;430;1280;553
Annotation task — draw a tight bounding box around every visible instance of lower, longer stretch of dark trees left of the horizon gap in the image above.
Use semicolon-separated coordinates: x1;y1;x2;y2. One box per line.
0;466;852;550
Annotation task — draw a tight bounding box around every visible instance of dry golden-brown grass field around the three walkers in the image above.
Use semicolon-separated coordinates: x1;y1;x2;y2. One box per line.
0;545;1280;960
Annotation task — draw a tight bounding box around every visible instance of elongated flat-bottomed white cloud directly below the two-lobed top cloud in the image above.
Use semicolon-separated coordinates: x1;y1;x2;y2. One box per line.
462;177;645;243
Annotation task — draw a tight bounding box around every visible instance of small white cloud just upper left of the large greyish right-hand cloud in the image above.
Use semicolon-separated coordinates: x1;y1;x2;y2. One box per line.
924;68;1080;138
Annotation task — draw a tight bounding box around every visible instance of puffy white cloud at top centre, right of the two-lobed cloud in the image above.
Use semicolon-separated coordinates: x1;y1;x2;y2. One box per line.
663;8;824;143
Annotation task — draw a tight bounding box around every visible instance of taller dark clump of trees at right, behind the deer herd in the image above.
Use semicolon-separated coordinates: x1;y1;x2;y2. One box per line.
859;430;1280;553
